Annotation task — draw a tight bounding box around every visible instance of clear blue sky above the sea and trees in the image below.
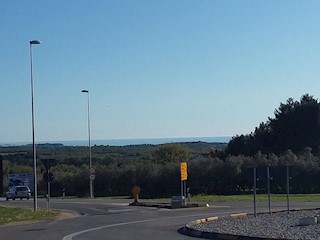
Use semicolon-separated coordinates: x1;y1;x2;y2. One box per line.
0;0;320;143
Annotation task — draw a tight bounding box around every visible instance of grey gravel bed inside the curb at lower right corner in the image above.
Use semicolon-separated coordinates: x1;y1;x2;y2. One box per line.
189;210;320;240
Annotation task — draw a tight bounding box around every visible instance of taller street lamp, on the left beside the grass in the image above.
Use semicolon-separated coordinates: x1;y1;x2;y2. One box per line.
29;40;41;211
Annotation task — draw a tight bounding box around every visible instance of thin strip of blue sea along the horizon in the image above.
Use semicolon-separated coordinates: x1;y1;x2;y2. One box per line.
0;136;232;146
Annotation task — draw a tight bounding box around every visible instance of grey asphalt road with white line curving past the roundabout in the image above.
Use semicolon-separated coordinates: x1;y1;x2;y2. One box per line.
0;199;320;240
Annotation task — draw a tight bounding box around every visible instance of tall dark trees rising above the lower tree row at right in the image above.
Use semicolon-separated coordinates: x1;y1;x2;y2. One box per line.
226;94;320;156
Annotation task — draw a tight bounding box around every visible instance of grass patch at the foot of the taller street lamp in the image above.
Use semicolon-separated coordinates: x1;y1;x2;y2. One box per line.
0;206;58;224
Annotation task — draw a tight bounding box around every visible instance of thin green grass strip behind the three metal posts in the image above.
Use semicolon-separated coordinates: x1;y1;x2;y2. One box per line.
191;194;320;202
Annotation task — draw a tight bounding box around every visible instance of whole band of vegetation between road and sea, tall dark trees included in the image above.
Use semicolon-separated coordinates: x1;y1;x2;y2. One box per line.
0;94;320;198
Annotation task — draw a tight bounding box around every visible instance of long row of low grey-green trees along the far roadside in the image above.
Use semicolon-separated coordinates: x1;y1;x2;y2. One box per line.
0;144;320;197
